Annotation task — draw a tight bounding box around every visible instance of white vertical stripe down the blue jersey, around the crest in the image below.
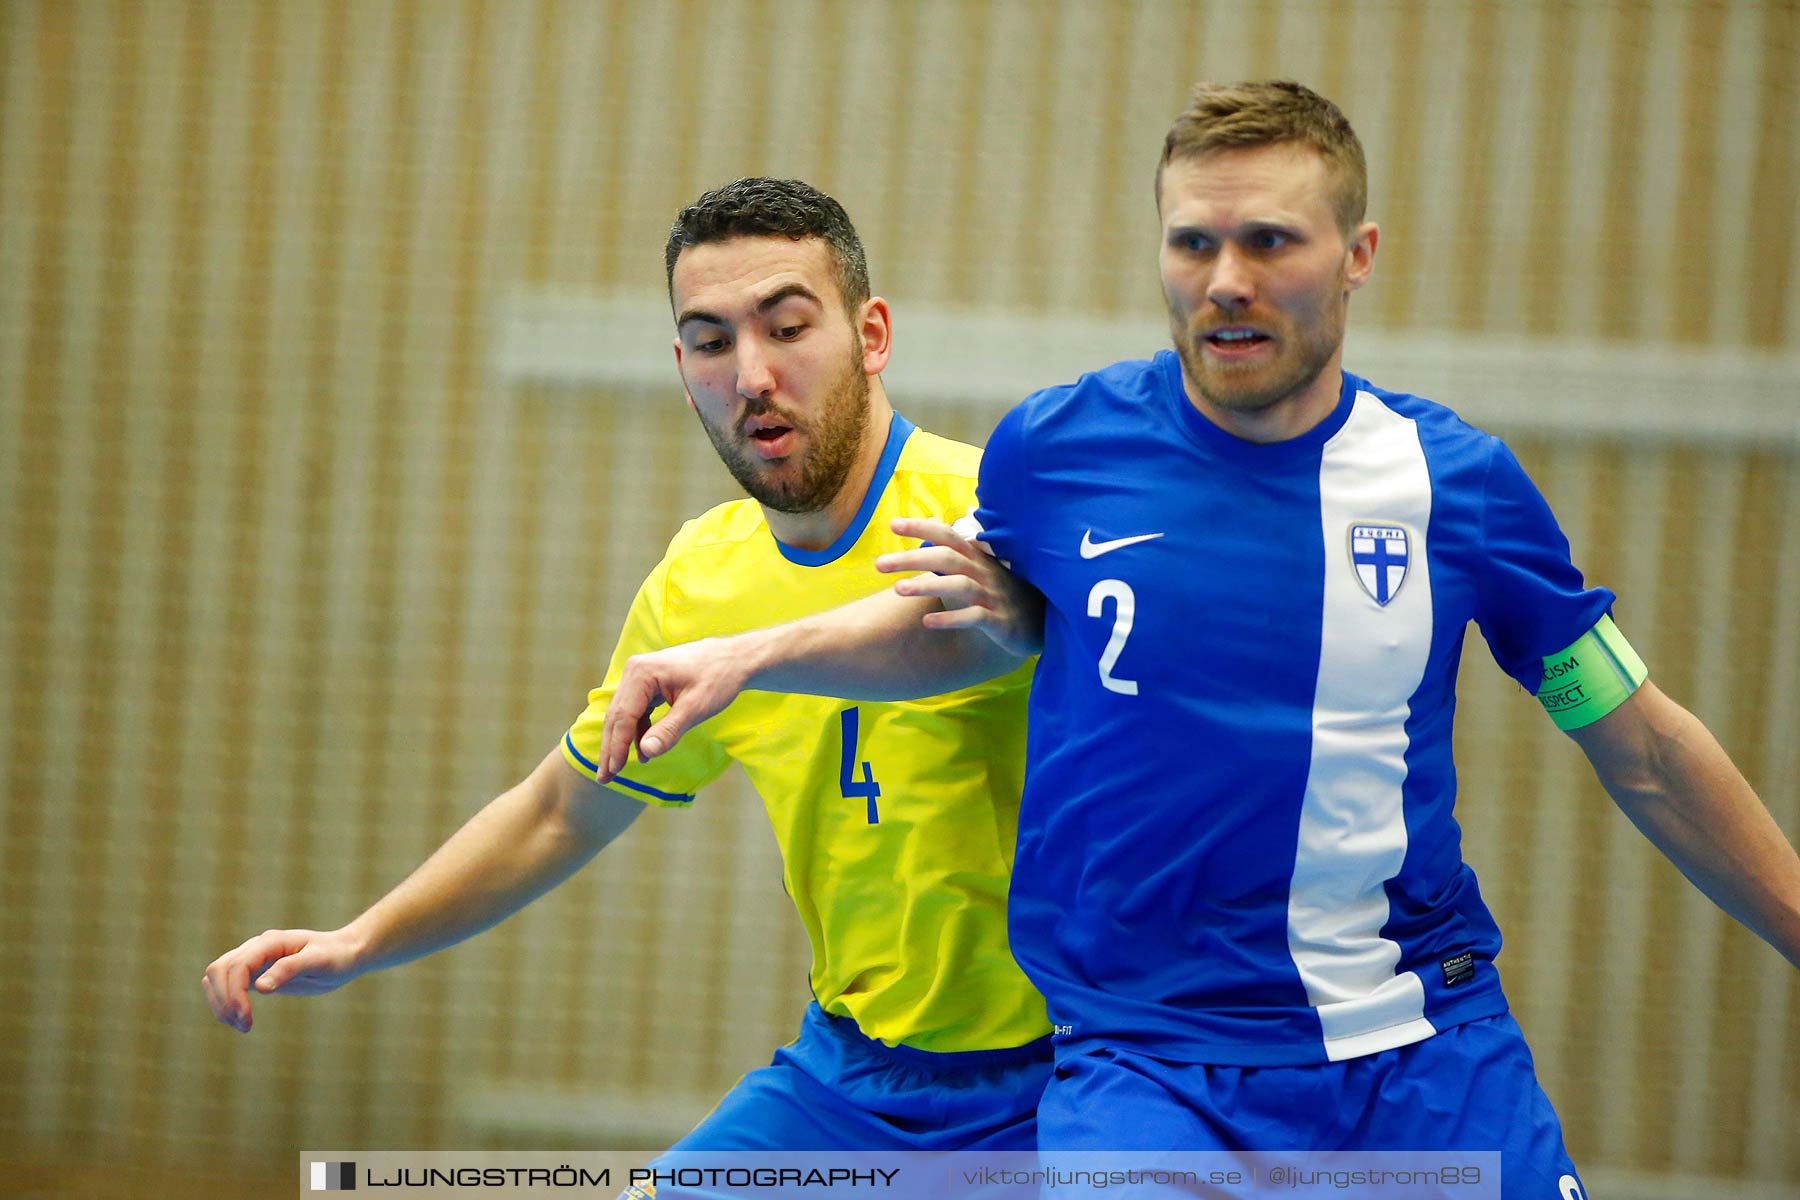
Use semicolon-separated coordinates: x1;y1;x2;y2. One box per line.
1287;392;1436;1061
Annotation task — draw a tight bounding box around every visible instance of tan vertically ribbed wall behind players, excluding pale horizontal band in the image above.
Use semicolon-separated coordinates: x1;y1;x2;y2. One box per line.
0;0;1800;1195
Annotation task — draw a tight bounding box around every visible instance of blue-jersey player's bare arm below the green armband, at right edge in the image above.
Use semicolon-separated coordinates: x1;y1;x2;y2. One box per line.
1570;684;1800;966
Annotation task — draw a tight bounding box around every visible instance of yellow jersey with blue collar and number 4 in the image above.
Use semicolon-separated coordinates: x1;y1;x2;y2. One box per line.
563;414;1049;1052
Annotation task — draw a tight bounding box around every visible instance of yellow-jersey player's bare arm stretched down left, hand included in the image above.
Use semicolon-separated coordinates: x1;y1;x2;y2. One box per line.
200;750;644;1033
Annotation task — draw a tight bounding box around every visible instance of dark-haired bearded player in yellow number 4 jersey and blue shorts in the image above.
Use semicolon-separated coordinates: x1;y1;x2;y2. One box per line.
203;178;1051;1150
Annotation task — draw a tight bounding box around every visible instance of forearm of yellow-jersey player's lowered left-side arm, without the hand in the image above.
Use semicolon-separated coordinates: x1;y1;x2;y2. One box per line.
344;763;610;973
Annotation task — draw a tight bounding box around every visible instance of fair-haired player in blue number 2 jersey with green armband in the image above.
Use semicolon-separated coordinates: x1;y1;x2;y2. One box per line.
603;81;1800;1200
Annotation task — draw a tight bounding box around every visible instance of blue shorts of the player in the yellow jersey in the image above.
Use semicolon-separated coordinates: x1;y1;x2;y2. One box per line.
670;1004;1051;1151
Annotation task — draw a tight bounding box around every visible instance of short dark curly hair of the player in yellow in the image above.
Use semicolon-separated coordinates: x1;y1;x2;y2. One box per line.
662;176;869;311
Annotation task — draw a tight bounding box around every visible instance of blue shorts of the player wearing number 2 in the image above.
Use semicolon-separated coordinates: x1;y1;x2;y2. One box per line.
1039;1013;1588;1200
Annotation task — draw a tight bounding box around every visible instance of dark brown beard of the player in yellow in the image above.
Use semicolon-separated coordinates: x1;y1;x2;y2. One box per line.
700;333;869;513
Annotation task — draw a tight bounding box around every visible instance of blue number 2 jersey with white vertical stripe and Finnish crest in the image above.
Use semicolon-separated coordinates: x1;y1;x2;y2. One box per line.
976;351;1613;1065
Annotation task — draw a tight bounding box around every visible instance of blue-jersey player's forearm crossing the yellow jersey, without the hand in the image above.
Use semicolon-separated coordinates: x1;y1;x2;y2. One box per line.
731;592;1022;700
